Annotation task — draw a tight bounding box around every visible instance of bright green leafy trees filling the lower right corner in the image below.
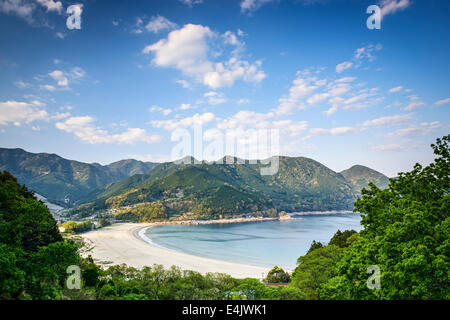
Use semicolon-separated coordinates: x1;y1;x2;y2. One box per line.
292;136;450;299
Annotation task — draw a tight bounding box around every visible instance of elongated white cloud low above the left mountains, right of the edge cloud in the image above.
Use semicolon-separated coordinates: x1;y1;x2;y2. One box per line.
55;116;161;144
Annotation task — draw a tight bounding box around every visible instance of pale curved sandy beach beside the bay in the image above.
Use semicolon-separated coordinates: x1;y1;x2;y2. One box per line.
81;223;270;279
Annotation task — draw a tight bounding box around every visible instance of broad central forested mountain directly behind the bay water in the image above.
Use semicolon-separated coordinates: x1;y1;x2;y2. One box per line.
74;157;388;217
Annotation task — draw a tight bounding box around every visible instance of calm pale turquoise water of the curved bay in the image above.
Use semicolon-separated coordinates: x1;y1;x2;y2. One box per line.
145;213;362;270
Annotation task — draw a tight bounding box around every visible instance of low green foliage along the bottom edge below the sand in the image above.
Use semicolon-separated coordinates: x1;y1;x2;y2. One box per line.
96;265;305;300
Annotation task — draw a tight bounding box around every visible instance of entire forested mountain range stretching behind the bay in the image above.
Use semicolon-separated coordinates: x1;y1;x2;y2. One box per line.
0;149;389;216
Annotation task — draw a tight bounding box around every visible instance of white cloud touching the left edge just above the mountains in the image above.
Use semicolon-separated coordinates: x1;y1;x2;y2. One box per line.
0;101;49;126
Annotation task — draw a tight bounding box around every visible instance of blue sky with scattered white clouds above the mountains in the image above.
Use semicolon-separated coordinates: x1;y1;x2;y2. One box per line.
0;0;450;176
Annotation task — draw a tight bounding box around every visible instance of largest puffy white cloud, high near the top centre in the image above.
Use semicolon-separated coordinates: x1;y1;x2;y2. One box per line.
142;24;266;89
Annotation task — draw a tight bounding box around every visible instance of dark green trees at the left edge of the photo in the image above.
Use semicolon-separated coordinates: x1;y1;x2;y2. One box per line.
0;172;80;299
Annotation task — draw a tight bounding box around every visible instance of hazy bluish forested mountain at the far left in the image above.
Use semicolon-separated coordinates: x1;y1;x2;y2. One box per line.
0;148;156;204
